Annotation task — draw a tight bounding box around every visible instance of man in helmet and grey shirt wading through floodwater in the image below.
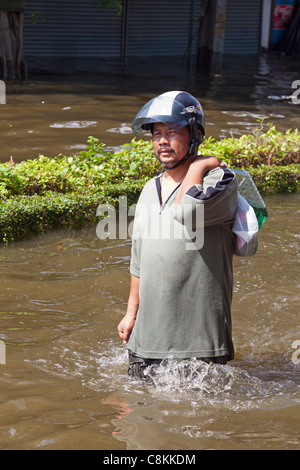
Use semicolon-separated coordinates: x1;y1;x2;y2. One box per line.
118;91;238;378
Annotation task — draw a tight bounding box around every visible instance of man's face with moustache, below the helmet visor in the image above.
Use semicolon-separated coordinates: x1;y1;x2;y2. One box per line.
152;123;190;169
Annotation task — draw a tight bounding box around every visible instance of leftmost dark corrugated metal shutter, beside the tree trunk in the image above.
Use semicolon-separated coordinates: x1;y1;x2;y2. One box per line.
24;0;122;58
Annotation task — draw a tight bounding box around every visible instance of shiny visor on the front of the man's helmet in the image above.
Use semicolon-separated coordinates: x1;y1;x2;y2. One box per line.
132;96;202;135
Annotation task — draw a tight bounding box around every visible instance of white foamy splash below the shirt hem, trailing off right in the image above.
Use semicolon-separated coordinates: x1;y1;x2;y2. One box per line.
140;359;299;409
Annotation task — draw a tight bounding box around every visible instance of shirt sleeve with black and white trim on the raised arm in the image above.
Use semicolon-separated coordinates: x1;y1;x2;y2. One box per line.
175;167;238;227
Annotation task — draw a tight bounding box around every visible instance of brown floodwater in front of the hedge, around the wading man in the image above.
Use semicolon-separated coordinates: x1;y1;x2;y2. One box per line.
0;194;300;450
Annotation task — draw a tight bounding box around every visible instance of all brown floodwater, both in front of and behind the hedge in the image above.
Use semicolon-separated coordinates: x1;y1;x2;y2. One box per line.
0;49;300;450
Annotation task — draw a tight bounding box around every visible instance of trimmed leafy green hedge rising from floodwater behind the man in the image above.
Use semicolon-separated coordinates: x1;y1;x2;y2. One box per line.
0;127;300;242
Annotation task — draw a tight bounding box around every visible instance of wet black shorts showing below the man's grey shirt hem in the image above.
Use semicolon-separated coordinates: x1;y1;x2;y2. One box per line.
128;349;228;379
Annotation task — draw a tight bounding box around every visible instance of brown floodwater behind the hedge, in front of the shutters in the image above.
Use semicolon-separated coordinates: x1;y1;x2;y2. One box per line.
0;54;300;162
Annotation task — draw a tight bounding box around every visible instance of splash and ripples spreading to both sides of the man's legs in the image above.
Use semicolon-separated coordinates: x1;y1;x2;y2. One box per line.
27;332;300;410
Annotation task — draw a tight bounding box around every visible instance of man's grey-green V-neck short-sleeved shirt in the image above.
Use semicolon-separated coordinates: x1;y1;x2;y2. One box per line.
127;167;238;360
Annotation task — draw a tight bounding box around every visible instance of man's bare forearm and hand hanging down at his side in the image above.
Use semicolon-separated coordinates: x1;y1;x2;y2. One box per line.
118;274;140;344
